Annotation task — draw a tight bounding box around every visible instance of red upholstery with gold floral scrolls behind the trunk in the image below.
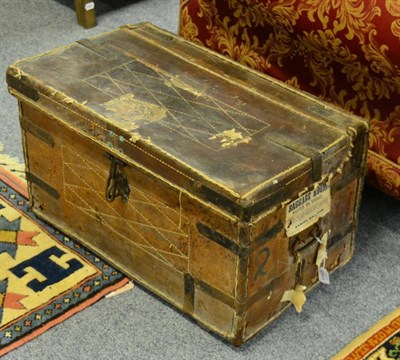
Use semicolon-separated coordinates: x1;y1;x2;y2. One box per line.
180;0;400;199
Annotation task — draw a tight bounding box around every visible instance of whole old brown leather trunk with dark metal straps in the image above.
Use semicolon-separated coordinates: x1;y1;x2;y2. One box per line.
7;24;368;345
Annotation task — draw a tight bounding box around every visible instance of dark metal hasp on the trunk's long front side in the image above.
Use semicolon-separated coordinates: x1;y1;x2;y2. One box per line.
105;153;131;202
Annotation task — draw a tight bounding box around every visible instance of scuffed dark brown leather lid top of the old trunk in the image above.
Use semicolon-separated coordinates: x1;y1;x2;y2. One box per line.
6;26;361;205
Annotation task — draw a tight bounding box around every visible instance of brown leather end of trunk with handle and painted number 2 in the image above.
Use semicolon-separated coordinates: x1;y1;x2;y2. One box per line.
245;169;363;337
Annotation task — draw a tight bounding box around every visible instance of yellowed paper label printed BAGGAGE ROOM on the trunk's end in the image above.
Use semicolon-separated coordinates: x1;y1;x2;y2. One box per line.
285;183;331;236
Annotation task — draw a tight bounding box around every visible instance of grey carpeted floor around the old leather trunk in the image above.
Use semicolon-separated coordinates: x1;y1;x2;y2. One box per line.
0;0;400;360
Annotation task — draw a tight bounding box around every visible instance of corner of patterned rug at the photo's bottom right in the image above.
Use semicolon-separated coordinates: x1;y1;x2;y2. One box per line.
332;308;400;360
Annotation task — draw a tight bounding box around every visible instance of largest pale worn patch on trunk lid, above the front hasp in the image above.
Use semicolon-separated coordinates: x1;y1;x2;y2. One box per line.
104;93;167;131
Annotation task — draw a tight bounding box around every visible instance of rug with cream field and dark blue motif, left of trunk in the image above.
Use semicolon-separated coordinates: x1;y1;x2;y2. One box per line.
0;166;128;356
